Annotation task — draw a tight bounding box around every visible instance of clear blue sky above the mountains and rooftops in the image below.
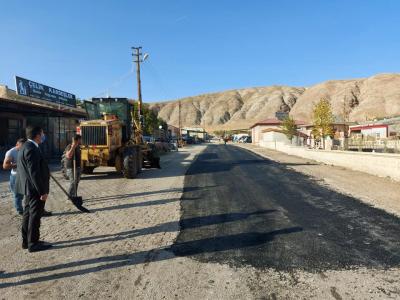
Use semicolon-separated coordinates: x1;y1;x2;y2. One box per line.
0;0;400;102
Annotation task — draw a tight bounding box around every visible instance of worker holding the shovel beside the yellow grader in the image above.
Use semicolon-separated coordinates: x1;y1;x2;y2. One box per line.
65;134;82;197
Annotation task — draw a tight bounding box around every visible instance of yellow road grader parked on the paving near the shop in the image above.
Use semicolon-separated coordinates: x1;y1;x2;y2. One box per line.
63;98;158;178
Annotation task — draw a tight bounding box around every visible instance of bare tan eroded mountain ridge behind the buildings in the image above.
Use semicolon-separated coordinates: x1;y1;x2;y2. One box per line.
150;74;400;130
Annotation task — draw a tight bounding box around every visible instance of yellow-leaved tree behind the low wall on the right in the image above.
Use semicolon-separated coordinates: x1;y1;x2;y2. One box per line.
312;98;335;149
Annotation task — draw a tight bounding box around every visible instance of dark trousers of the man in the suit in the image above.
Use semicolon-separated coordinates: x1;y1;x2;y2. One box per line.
22;195;45;248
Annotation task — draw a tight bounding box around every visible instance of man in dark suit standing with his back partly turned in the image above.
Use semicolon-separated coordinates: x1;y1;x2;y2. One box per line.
16;127;51;252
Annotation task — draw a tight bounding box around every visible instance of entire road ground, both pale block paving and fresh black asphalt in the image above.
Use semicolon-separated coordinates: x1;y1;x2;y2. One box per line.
0;144;400;299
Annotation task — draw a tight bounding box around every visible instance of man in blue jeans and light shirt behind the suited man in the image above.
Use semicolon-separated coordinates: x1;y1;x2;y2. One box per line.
3;139;26;216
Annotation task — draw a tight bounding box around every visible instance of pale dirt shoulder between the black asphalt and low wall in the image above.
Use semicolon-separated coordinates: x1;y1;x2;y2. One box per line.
234;144;400;216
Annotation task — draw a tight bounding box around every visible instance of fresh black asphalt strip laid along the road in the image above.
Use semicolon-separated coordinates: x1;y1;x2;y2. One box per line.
172;145;400;272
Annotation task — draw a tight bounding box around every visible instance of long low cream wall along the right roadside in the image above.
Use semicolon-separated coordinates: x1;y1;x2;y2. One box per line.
260;141;400;181
